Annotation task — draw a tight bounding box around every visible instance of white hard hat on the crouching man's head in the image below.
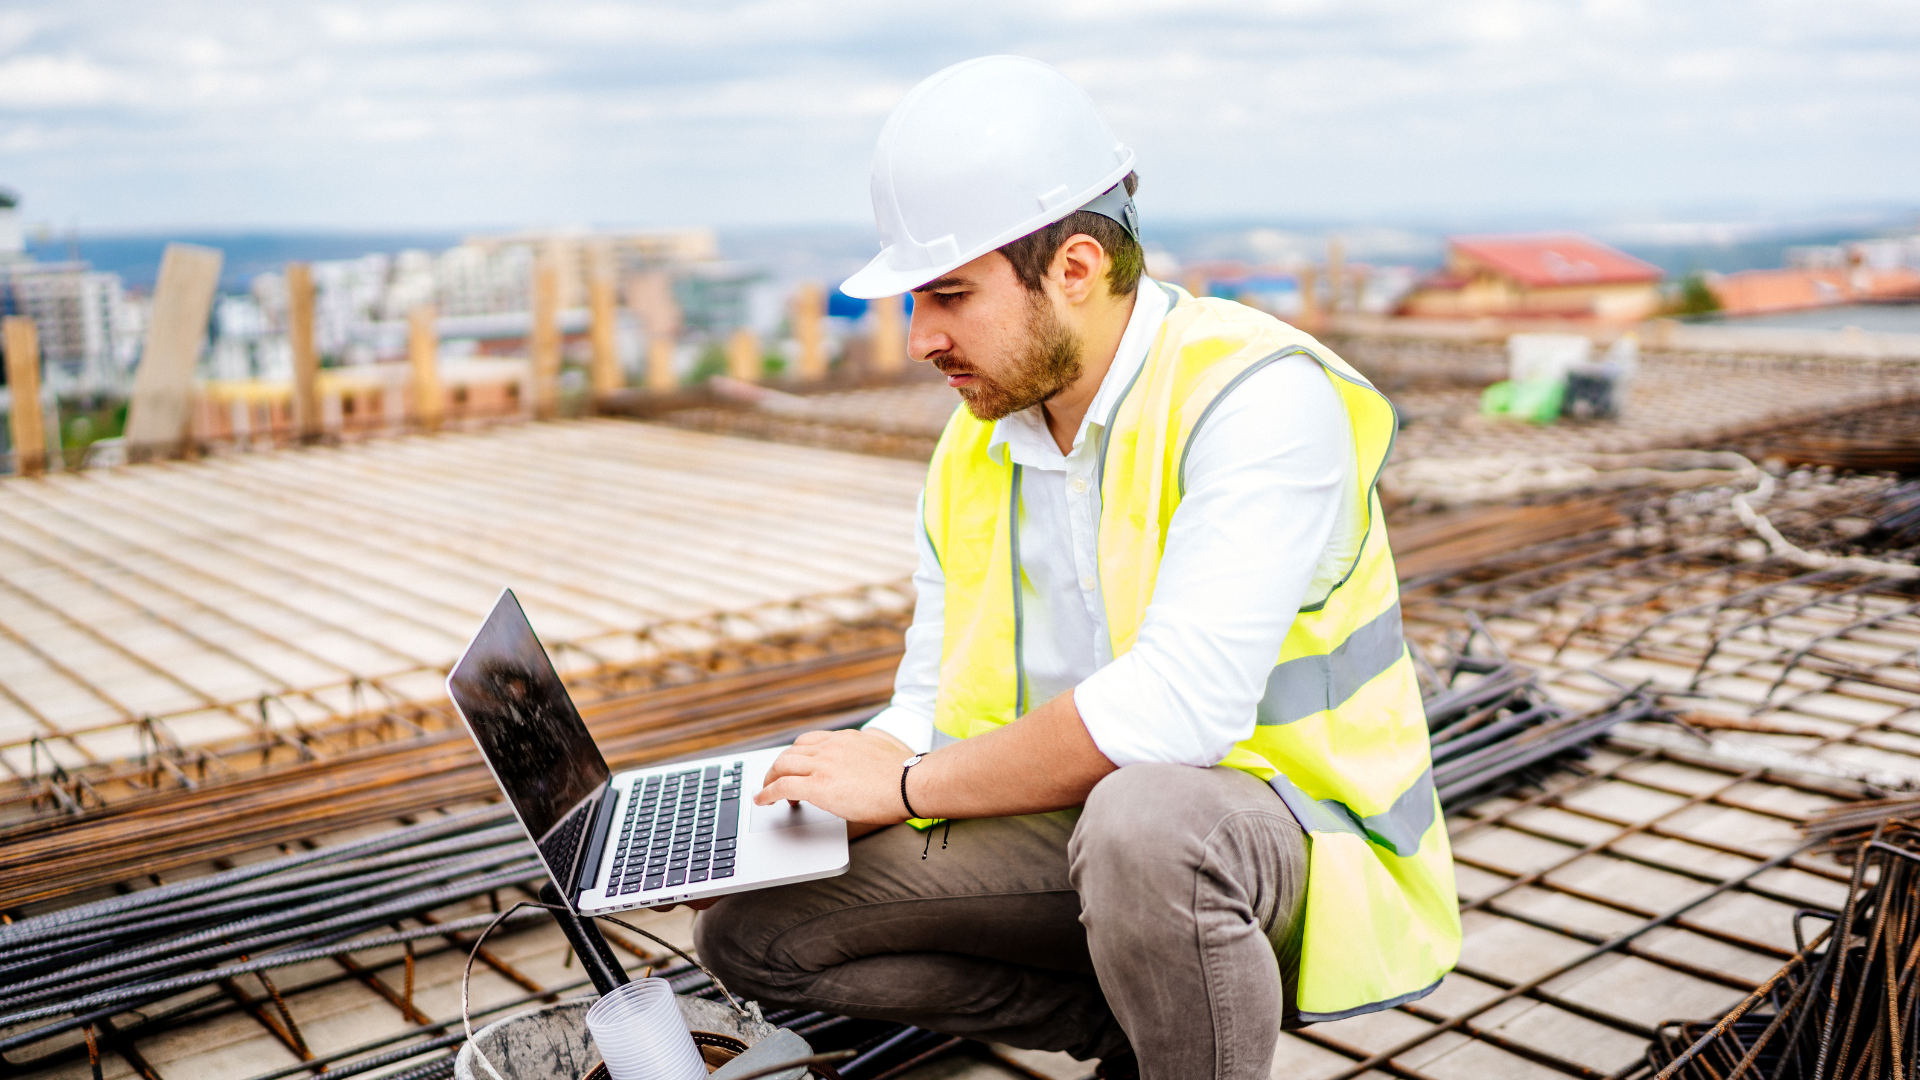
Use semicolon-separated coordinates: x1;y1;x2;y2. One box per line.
841;56;1135;300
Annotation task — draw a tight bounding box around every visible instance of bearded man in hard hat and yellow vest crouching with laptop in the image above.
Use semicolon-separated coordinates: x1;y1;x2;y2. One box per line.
695;56;1459;1080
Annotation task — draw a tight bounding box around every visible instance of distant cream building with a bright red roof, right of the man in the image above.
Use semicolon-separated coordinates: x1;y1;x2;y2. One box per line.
1400;234;1661;323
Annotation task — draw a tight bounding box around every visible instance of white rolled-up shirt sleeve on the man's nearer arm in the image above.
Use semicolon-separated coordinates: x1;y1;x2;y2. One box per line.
1082;356;1356;767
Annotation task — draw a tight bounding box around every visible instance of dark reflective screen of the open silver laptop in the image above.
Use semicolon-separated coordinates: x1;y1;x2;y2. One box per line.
447;590;611;876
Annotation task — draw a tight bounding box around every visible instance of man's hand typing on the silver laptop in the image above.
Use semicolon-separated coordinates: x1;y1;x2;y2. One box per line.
753;730;914;826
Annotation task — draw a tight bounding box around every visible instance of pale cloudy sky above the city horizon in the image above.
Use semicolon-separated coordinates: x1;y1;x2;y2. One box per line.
0;0;1920;233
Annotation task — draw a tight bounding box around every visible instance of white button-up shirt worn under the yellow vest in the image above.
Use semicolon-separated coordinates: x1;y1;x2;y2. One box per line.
866;279;1356;767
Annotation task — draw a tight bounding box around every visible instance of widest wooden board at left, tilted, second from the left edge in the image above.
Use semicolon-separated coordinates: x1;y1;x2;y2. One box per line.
127;244;223;461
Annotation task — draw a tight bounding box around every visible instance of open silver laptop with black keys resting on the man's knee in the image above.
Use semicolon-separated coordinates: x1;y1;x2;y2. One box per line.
447;590;847;915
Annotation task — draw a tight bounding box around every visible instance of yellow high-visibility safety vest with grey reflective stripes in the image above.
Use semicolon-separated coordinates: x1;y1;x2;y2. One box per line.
925;281;1461;1022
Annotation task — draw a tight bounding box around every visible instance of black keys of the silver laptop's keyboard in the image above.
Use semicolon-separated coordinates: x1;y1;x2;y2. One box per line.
607;761;743;896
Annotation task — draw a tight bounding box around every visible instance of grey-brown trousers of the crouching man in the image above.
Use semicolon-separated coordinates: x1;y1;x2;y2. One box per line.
693;765;1308;1080
